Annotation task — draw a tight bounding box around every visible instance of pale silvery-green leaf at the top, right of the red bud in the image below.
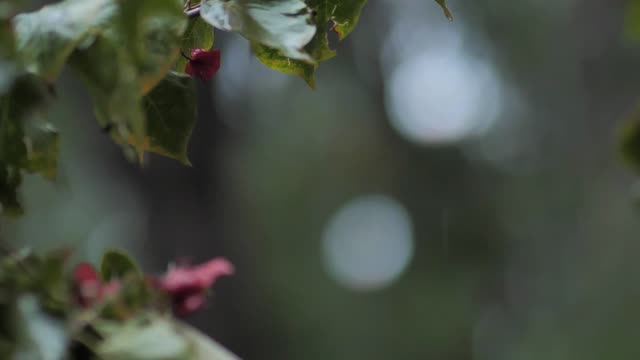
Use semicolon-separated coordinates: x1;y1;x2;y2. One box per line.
200;0;316;63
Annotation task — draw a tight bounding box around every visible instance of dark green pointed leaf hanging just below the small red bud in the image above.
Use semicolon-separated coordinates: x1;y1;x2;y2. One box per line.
143;72;197;165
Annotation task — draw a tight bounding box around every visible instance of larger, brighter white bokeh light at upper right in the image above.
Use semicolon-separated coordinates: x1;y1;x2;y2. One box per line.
386;49;503;145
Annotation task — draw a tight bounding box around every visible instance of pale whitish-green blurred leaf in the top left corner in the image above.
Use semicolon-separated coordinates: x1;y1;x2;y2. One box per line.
13;0;116;81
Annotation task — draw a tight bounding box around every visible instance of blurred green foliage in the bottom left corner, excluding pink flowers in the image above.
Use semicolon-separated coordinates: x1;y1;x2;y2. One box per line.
0;250;237;360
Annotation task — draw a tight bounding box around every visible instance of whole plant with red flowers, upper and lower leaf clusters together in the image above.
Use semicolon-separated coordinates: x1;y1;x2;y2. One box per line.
0;0;450;360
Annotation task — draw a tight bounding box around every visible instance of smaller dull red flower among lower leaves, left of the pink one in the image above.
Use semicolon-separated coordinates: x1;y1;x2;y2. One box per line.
73;263;120;308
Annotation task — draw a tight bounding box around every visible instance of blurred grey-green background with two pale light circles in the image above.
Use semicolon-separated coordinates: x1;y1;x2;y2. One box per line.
2;0;640;360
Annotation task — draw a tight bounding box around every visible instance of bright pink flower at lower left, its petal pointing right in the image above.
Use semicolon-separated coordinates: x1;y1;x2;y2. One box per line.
157;258;234;314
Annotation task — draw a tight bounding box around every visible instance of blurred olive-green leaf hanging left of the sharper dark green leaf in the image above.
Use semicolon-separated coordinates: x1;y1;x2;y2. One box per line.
71;0;187;160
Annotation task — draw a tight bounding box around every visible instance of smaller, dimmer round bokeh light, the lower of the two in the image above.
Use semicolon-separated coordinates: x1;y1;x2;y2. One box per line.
322;195;414;290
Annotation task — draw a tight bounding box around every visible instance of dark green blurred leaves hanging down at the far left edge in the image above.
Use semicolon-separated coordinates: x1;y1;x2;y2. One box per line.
0;74;58;214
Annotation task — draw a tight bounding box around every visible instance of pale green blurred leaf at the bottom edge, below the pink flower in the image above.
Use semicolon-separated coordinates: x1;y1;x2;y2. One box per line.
96;315;190;360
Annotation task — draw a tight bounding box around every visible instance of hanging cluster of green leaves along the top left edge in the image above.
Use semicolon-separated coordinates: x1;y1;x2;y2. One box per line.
0;0;450;214
